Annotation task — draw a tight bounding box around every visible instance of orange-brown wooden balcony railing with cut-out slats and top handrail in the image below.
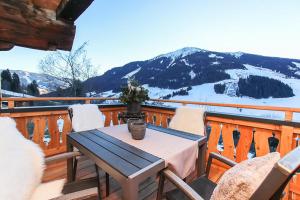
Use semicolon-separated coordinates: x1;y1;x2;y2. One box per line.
0;98;300;199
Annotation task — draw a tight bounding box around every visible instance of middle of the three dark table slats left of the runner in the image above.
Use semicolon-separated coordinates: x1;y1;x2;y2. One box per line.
82;131;152;169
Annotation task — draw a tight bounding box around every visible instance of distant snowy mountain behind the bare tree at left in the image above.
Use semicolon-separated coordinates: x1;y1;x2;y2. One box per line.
0;69;65;94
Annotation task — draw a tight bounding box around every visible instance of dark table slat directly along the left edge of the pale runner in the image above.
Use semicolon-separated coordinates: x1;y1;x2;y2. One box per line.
90;130;161;163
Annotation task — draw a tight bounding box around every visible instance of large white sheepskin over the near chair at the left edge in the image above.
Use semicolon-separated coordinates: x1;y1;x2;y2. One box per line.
0;117;44;200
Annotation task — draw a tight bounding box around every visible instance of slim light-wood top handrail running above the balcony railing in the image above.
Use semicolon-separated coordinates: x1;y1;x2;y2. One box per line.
1;97;300;113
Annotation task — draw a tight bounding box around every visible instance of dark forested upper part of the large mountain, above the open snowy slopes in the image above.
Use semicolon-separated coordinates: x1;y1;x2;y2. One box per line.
85;47;300;99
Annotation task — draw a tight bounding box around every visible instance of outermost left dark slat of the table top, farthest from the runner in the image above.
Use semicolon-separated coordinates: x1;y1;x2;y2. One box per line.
69;132;140;177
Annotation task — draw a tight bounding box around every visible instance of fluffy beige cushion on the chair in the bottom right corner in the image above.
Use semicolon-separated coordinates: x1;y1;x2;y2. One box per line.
211;152;280;200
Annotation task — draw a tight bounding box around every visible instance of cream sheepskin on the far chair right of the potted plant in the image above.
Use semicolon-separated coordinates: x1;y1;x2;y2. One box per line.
169;106;205;135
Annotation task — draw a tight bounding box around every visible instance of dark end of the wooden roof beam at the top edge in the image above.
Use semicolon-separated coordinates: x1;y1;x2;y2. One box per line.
56;0;94;22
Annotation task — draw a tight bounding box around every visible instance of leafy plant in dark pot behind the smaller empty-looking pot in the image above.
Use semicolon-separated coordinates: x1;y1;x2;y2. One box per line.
120;79;149;114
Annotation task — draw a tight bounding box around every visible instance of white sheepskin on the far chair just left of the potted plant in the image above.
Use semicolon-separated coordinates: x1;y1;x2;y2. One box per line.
70;104;104;132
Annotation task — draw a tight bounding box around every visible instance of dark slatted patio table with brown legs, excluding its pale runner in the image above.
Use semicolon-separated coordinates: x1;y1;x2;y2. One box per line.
67;125;206;200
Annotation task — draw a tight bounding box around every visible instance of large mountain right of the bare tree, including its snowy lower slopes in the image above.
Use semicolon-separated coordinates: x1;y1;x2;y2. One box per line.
85;48;300;119
